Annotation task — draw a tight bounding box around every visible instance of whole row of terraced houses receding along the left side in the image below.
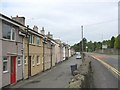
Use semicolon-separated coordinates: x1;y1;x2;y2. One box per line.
0;14;75;88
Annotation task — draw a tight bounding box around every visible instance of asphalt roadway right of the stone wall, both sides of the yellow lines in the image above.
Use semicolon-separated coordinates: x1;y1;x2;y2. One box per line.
89;53;119;88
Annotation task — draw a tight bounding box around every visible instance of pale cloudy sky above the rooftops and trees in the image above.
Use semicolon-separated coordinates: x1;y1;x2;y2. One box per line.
0;0;119;45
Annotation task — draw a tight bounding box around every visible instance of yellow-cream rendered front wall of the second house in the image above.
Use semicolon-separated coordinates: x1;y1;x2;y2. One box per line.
24;38;43;79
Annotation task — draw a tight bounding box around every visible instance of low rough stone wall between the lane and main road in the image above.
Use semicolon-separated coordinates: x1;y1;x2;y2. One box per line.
68;56;92;88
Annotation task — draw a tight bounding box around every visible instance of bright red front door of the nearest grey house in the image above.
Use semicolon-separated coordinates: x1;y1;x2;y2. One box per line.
10;56;16;84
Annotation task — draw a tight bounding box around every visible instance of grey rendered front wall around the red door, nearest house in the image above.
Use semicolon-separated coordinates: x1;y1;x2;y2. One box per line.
2;22;23;86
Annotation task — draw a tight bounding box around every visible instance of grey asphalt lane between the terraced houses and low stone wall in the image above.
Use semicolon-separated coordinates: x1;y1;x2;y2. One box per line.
12;56;81;88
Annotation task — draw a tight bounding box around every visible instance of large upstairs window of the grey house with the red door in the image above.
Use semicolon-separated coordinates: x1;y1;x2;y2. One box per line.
2;23;15;40
